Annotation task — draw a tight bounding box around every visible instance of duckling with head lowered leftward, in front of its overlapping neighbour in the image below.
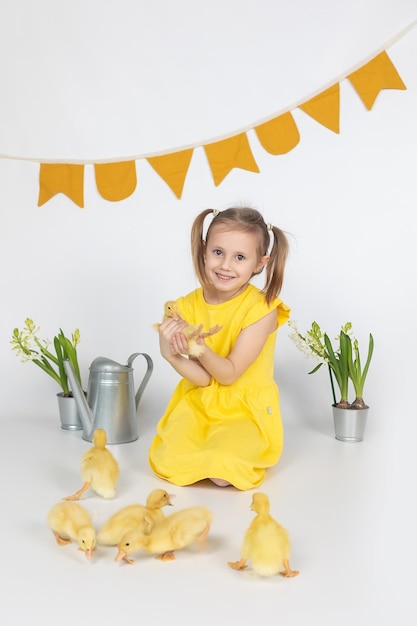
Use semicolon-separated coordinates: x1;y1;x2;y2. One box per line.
115;506;213;564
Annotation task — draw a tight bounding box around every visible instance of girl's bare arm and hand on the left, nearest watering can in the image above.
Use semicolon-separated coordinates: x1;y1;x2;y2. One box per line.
159;318;211;387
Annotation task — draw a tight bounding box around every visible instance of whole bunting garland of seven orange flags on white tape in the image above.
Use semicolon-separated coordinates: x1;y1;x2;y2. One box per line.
0;50;407;208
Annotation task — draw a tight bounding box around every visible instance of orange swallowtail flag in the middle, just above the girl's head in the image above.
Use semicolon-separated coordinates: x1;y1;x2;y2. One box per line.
203;133;259;186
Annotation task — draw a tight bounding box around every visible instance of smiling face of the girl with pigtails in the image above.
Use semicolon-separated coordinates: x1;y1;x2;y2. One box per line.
205;226;269;302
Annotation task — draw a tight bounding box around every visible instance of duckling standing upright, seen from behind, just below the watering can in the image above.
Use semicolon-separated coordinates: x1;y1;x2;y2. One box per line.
63;428;120;500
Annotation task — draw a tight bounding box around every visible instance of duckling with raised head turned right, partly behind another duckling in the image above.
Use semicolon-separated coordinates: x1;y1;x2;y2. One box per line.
97;489;172;546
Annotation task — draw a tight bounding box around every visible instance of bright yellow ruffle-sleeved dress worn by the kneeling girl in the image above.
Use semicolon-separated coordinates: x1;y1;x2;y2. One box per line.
149;285;290;490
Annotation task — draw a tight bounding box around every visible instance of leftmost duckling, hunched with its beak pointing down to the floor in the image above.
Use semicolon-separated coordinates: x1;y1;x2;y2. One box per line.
47;502;96;561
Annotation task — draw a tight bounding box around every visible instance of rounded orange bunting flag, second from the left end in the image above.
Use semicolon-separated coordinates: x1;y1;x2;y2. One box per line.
94;161;137;202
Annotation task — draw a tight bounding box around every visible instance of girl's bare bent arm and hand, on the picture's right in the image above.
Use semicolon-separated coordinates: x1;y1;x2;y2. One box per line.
171;309;277;385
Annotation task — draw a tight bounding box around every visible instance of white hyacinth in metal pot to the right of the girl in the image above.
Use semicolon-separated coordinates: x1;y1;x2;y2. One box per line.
288;320;374;441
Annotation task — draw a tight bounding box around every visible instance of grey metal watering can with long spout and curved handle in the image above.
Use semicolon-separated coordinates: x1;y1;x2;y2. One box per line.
64;352;153;443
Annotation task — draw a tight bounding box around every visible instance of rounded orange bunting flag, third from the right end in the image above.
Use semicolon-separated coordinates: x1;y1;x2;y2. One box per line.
254;113;300;154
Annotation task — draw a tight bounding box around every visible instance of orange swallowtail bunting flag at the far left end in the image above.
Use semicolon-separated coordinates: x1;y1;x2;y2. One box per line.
38;163;84;208
